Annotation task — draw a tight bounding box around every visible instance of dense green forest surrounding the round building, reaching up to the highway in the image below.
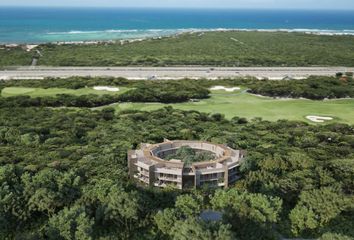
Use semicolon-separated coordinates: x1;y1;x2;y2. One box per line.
0;77;354;240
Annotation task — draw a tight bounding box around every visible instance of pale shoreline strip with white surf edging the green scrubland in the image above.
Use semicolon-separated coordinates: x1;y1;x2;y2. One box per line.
0;28;354;45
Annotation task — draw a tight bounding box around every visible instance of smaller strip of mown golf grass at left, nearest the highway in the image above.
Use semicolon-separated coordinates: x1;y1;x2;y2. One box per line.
1;87;129;97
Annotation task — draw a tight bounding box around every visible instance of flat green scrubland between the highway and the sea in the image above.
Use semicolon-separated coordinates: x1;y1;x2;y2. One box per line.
0;31;354;66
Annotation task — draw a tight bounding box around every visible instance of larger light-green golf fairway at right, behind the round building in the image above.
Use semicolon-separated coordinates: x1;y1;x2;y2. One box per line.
110;91;354;124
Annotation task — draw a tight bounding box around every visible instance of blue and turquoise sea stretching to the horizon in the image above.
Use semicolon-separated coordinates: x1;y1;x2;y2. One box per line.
0;7;354;43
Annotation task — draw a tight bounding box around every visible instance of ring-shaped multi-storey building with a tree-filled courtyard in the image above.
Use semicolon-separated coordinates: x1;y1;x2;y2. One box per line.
128;140;245;189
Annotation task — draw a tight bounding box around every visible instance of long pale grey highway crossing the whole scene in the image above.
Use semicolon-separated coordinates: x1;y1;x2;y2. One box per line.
0;66;354;80
